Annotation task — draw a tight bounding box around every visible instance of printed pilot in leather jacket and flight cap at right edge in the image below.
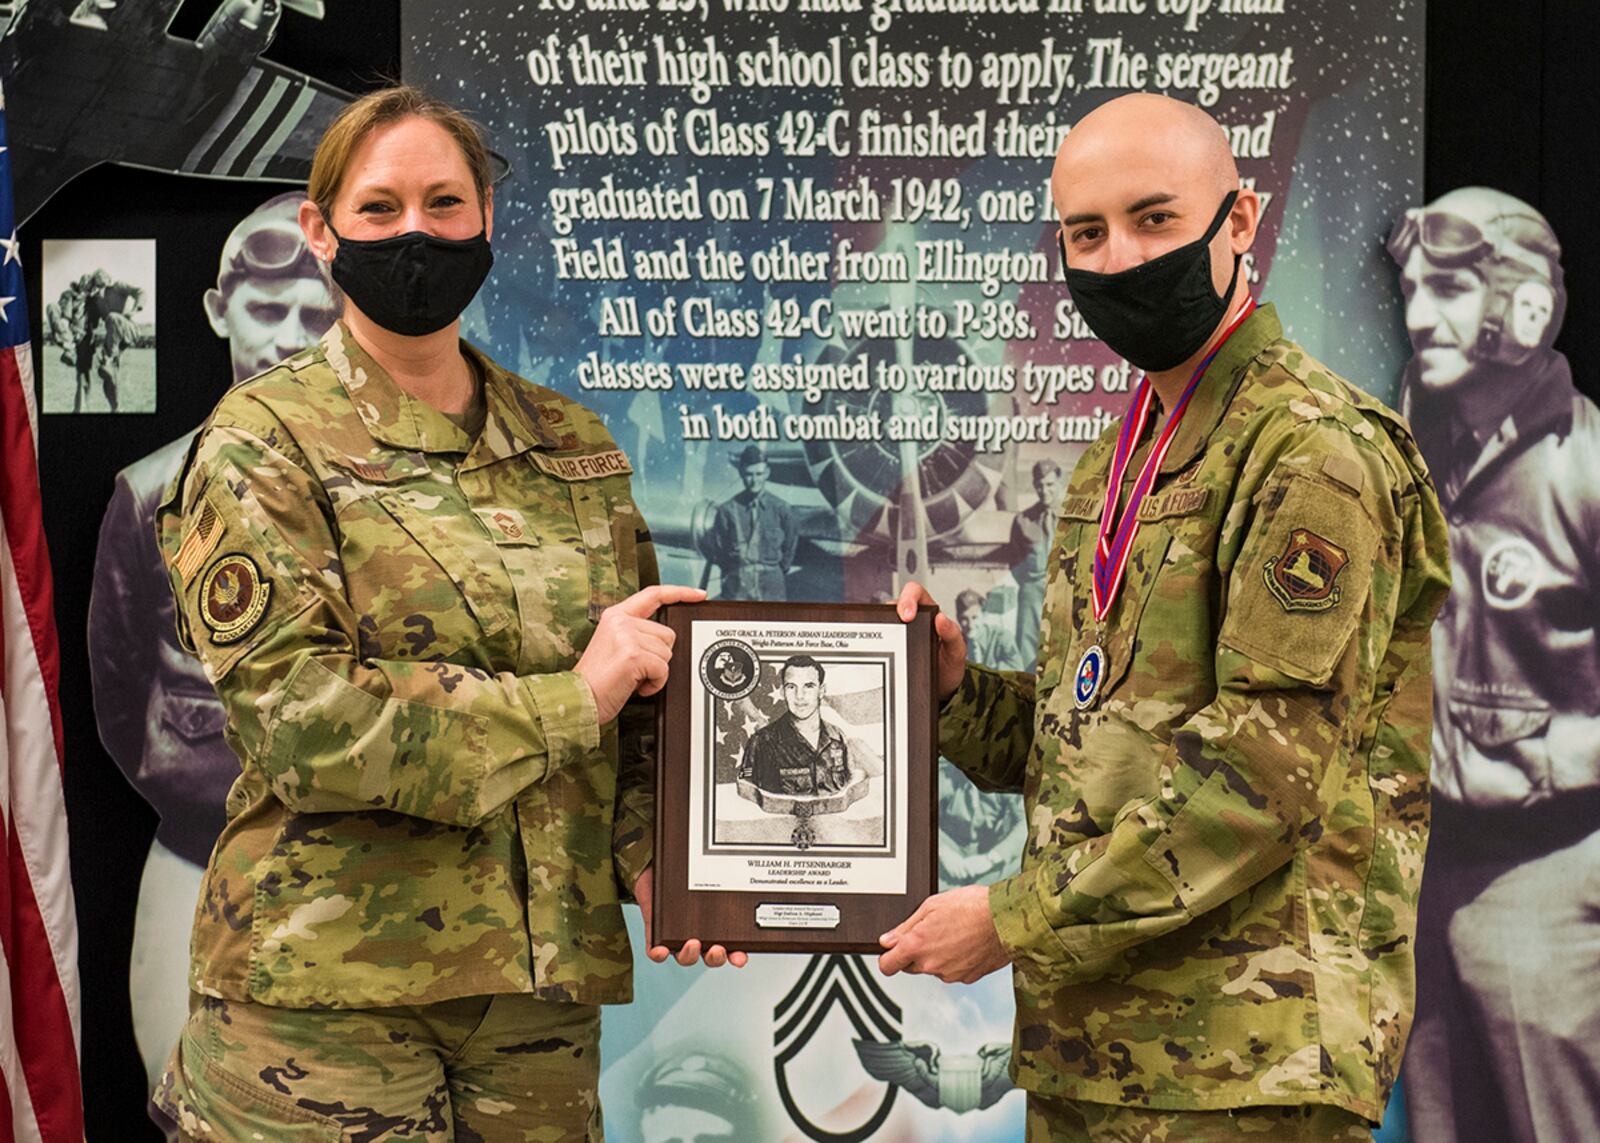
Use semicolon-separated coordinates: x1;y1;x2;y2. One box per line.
1389;187;1600;1143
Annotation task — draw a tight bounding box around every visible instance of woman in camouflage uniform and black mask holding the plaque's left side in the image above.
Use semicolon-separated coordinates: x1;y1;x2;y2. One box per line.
157;88;742;1141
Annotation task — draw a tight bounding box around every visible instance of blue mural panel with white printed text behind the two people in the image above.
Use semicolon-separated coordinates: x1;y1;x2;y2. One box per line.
403;0;1422;1143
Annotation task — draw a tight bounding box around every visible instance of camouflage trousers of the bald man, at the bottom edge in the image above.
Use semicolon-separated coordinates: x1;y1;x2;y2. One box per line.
1027;1092;1373;1143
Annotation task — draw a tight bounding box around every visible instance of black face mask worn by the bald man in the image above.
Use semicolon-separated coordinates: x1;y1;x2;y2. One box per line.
1056;191;1240;373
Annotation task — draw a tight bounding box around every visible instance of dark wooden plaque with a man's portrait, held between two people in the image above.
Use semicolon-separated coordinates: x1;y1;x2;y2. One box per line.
651;602;939;953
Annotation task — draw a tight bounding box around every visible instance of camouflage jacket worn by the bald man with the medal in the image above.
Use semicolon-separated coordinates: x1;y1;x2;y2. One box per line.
941;307;1450;1119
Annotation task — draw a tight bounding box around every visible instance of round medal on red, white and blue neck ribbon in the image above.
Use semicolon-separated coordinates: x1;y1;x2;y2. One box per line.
1072;295;1256;711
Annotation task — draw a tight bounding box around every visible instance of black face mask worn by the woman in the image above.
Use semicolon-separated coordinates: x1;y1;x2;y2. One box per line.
328;224;494;338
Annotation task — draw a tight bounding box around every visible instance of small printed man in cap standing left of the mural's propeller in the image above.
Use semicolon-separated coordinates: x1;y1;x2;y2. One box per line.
706;445;800;602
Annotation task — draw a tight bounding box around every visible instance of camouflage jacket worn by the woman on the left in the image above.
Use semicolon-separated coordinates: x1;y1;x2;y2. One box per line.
157;323;656;1007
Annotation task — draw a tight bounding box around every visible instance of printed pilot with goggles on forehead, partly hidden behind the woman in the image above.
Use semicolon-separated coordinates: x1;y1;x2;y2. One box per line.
88;192;338;1089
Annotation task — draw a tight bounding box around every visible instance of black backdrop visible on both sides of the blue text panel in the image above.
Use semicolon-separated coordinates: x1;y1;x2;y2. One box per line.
22;0;1600;1140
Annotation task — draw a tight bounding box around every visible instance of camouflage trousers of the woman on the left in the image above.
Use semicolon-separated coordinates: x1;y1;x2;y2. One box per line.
152;994;602;1143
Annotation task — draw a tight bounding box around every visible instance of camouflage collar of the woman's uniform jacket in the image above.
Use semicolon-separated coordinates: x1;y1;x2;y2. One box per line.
322;320;571;466
